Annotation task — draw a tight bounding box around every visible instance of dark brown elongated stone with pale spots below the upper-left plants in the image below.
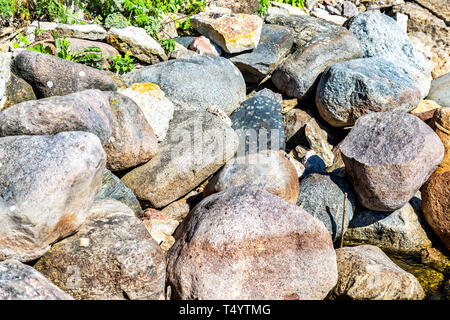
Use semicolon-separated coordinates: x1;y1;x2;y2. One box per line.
14;50;117;98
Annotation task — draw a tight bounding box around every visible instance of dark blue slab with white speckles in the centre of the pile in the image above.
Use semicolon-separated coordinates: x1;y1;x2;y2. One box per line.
230;95;286;156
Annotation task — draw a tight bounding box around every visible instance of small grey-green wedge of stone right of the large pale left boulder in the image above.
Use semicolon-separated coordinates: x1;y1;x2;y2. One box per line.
95;169;142;217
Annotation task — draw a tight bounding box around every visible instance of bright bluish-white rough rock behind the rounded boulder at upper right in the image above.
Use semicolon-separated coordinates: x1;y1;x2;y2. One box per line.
345;12;432;98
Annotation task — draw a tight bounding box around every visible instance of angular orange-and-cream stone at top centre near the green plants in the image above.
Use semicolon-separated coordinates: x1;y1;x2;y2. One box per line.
191;13;263;53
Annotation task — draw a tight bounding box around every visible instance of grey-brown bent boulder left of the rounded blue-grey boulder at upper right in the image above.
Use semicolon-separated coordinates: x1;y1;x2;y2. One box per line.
271;16;363;98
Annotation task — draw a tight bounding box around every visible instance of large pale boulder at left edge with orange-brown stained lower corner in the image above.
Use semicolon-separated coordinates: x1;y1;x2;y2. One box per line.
0;132;106;262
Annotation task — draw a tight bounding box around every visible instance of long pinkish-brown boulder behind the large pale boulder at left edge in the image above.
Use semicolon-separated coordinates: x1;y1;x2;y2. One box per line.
0;90;158;170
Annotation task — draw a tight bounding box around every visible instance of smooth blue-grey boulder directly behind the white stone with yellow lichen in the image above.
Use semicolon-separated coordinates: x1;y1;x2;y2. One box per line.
124;56;245;115
